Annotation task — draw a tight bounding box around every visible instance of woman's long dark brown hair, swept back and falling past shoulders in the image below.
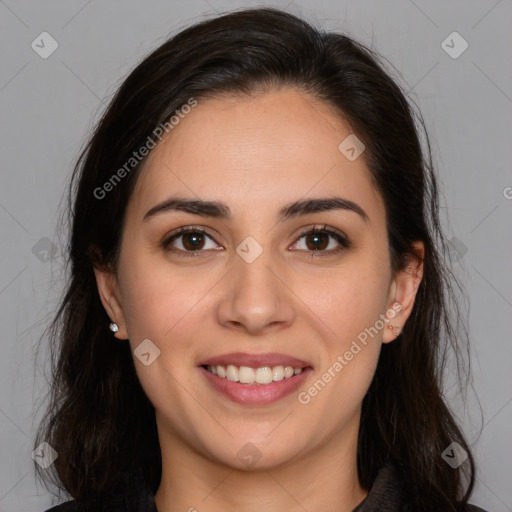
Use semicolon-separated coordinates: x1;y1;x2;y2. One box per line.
36;8;474;510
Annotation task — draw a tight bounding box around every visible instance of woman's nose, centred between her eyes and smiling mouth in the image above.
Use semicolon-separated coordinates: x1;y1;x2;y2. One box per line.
217;250;296;335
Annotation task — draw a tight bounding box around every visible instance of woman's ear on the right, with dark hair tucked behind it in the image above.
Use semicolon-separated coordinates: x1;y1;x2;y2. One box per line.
382;241;425;343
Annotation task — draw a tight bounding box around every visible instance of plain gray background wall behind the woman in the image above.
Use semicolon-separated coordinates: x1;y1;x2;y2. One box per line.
0;0;512;512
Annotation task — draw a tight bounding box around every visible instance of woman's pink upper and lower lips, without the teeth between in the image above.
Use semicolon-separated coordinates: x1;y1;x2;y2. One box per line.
199;352;313;405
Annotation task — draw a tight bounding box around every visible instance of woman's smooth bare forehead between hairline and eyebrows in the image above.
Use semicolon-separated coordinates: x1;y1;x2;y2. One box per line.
129;89;383;226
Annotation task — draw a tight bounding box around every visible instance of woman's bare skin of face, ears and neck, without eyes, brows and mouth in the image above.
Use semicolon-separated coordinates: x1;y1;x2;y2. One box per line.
96;88;423;512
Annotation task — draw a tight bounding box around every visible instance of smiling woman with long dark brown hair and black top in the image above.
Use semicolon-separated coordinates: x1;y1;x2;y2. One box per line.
37;9;488;512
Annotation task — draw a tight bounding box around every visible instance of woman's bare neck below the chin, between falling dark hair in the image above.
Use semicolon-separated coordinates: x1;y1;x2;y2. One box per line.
155;420;368;512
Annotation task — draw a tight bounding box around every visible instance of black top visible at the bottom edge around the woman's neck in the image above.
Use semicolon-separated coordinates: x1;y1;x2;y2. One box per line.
47;467;485;512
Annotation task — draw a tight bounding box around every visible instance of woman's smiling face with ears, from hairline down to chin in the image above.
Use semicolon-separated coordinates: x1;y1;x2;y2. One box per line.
96;89;418;468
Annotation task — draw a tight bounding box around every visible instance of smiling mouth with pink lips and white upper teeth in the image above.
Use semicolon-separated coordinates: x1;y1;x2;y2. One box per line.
198;353;313;405
